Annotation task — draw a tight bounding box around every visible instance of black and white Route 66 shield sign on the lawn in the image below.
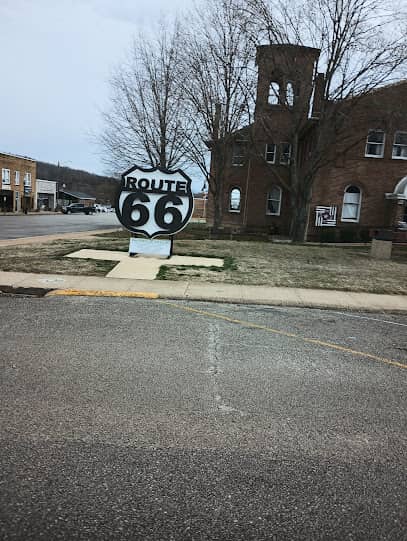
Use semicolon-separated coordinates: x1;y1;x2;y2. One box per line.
116;165;194;239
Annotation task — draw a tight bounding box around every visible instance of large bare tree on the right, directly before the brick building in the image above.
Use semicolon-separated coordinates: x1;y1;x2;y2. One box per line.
241;0;407;241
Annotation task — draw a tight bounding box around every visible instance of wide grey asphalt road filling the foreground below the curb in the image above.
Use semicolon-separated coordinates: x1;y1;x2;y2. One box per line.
0;296;407;541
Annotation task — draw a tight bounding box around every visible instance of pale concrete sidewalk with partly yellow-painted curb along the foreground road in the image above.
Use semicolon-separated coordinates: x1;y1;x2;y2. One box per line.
0;271;407;313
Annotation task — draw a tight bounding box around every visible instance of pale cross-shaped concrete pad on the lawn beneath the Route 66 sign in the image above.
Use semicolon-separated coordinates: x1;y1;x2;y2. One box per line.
65;250;223;280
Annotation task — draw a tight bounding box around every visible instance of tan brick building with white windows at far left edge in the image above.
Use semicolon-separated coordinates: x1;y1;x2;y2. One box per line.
0;153;37;212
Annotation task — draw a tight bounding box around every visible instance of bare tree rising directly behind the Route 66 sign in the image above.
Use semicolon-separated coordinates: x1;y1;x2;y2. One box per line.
100;24;190;173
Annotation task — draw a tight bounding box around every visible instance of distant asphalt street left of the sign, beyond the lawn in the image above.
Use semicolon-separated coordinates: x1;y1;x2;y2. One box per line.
0;212;120;240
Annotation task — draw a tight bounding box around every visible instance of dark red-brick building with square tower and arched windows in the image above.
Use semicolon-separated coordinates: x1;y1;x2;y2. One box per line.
208;45;407;240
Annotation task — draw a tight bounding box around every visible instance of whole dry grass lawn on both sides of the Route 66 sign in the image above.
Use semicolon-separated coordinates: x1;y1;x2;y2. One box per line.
0;224;407;295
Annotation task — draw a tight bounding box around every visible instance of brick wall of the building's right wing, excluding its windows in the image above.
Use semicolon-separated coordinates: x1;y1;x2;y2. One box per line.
309;82;407;240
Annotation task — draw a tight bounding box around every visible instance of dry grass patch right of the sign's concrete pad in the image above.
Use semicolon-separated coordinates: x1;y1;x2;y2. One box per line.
164;240;407;294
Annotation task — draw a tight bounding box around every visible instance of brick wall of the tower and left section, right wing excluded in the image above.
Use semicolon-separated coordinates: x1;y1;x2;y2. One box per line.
208;45;319;235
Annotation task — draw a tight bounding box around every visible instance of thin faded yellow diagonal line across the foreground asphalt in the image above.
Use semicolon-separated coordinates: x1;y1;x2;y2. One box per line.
159;300;407;369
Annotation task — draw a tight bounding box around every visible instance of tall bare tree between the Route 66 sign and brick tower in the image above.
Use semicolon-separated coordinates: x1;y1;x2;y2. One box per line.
182;0;254;231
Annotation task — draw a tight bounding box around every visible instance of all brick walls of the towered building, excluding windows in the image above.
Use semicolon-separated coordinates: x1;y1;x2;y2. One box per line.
208;46;407;240
